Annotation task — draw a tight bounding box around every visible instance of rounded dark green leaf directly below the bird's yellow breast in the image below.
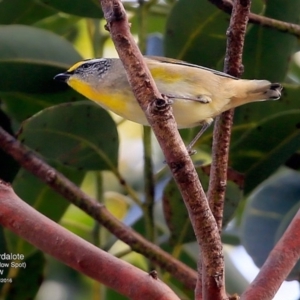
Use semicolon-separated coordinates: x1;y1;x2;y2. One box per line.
19;101;118;170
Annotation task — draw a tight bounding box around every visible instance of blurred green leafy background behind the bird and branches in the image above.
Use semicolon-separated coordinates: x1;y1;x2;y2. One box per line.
0;0;300;300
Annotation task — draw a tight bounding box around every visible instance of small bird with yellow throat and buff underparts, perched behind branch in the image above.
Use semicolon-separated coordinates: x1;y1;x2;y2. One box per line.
54;57;282;148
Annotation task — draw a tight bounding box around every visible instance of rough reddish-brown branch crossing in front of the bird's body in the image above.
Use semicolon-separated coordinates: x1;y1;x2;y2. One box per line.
100;0;227;300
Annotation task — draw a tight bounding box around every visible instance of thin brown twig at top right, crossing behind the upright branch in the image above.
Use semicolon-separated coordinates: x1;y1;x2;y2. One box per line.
209;0;300;38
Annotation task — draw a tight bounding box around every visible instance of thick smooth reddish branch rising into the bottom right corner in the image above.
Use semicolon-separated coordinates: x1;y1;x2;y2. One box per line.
241;210;300;300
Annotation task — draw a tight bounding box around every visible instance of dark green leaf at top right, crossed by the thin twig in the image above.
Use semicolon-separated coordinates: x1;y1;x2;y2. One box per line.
243;0;300;82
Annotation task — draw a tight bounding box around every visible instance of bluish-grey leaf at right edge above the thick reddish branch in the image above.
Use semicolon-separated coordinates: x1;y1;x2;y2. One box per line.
241;168;300;274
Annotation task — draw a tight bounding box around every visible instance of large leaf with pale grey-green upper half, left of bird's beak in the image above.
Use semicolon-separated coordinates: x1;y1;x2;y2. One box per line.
0;25;80;93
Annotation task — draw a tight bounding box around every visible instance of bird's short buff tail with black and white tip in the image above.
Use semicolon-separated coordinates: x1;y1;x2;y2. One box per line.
232;80;282;106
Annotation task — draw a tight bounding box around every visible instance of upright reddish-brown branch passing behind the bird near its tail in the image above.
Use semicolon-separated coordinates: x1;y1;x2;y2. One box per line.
208;0;251;231
